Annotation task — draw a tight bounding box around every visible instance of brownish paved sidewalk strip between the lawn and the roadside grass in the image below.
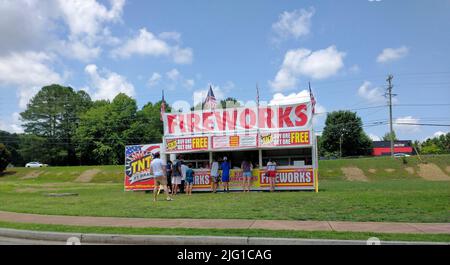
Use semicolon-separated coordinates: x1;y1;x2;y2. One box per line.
0;211;450;234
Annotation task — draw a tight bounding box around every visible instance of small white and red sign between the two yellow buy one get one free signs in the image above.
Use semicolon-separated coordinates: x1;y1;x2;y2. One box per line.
211;134;258;150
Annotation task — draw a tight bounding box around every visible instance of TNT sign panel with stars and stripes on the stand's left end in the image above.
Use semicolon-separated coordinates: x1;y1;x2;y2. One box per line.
124;144;161;190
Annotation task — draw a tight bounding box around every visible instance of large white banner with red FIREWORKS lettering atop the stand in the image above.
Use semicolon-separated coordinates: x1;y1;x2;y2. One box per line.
164;102;312;137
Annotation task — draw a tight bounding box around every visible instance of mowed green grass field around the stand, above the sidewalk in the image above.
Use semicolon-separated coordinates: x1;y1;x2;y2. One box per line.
0;155;450;223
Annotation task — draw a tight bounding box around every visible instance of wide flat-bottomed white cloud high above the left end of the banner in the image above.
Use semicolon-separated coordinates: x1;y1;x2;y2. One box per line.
111;28;193;64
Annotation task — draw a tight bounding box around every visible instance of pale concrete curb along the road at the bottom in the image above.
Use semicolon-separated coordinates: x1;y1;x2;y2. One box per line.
0;228;450;245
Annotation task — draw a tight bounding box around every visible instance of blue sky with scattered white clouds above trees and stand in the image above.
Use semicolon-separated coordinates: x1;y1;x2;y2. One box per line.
0;0;450;140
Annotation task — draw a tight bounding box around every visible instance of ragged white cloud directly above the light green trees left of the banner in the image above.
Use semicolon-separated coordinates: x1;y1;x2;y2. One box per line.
85;64;135;100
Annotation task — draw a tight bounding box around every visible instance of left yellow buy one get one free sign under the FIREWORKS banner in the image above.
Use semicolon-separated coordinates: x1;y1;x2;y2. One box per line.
165;136;209;153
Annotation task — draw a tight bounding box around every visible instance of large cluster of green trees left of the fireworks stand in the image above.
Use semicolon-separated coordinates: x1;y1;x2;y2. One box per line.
0;84;170;166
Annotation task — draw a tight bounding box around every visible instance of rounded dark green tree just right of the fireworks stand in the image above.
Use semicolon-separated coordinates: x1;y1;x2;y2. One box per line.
321;110;372;156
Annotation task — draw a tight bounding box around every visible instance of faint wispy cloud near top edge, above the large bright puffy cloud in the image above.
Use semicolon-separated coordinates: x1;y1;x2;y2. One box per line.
272;8;314;39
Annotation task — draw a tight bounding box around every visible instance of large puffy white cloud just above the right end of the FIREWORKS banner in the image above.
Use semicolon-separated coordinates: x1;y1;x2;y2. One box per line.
269;45;345;91
